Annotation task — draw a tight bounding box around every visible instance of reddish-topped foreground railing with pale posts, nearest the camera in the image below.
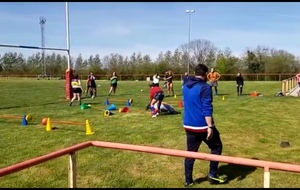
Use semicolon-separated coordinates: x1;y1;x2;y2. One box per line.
0;141;300;188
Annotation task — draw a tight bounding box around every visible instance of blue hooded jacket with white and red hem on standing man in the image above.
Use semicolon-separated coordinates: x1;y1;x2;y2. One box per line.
182;76;213;132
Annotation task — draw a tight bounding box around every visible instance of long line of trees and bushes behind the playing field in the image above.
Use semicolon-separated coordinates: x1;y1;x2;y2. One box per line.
0;39;300;76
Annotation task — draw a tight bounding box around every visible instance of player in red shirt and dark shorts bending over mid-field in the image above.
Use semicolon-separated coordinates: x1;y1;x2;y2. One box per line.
150;81;165;118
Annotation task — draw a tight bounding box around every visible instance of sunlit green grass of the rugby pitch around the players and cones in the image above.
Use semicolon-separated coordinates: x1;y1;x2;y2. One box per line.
0;80;300;188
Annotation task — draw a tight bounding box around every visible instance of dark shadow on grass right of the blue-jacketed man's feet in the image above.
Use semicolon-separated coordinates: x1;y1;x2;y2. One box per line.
218;161;256;182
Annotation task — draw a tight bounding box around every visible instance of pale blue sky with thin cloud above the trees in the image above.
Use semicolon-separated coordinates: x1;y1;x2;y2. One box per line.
0;2;300;58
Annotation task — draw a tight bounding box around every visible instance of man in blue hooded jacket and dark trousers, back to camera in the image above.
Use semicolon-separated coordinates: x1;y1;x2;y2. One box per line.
182;64;226;186
